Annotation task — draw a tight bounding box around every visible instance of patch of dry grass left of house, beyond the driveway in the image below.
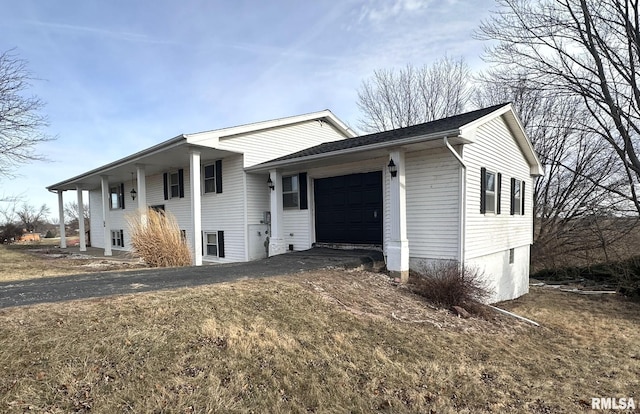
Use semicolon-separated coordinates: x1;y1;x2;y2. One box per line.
0;244;141;283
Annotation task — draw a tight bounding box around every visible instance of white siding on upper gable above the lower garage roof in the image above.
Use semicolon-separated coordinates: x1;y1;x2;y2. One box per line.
216;121;345;168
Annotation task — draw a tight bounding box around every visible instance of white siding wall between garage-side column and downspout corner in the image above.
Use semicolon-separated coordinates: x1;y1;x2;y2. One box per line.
405;148;460;259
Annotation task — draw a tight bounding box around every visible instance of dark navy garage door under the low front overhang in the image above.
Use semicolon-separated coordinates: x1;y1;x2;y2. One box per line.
314;171;382;244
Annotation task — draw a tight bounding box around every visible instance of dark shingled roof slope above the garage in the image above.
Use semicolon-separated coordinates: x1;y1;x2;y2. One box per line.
263;103;508;164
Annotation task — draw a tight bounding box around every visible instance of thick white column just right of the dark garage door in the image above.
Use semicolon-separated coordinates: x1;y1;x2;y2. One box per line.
387;151;409;283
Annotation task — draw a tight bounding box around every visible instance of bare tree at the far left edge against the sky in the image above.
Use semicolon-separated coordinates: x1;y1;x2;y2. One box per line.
0;51;53;177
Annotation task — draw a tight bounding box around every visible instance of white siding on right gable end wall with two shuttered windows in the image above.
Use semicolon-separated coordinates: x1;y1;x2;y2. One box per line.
464;118;533;259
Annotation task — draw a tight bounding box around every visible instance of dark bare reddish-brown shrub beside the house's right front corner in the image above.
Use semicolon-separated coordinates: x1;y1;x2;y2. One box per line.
409;261;493;311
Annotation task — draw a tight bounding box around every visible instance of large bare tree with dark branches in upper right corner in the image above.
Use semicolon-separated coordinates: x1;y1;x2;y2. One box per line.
478;0;640;213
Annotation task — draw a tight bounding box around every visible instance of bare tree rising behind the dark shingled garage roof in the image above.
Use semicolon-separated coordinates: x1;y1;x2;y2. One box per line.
357;57;471;132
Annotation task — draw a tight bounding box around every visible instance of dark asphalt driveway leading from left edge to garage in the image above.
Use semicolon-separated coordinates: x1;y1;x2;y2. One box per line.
0;248;383;308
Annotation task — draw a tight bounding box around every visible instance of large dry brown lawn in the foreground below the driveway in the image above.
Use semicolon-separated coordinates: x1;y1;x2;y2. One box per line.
0;264;640;413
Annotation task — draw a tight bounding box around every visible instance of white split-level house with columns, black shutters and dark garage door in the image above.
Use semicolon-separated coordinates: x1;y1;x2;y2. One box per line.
47;104;542;301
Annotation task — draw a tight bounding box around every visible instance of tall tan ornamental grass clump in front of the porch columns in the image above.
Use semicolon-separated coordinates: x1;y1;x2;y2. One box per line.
127;209;191;267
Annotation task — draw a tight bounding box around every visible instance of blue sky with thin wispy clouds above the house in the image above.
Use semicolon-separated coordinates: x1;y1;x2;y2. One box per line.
0;0;494;215
